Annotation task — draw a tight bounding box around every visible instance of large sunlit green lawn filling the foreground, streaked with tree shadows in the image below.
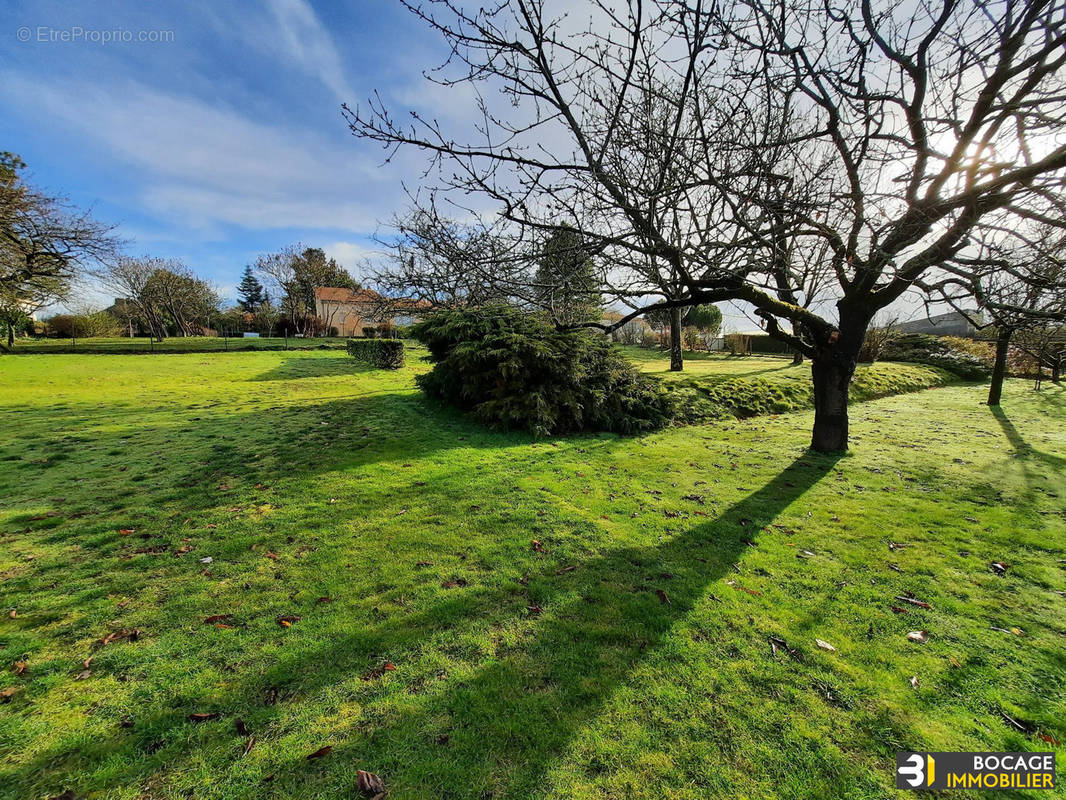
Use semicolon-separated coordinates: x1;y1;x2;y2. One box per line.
0;351;1066;800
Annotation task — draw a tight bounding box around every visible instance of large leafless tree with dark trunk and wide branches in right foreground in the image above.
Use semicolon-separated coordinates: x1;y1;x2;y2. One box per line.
345;0;1066;450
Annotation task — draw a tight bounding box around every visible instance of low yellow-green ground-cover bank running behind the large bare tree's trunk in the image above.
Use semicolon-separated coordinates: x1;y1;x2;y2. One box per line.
666;364;955;423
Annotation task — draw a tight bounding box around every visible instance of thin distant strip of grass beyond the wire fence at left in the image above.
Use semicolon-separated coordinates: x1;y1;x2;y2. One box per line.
11;336;345;355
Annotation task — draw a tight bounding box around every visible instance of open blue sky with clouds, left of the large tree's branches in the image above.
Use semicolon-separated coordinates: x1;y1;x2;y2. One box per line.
0;0;450;295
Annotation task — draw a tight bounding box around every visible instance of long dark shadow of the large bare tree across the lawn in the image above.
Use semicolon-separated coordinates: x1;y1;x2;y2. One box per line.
0;453;839;798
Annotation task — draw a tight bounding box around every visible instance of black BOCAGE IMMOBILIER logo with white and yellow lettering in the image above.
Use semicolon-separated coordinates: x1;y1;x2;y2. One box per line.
895;752;1055;789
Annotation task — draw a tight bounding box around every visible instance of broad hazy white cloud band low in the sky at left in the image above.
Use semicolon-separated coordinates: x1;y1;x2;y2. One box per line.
0;73;404;233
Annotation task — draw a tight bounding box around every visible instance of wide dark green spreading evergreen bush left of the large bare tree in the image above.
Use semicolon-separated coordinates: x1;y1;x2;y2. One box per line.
411;306;674;435
